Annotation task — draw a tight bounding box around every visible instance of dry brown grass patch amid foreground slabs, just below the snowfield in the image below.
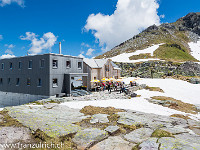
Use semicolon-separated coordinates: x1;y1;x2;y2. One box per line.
80;106;124;115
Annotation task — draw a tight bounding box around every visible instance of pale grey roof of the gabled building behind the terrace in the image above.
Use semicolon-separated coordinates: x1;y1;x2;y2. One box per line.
83;58;120;69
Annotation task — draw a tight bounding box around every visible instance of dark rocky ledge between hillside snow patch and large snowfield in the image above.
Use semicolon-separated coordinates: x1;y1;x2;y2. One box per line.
117;61;200;80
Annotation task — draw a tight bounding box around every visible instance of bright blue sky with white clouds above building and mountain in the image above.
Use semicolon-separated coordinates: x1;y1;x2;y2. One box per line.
0;0;200;57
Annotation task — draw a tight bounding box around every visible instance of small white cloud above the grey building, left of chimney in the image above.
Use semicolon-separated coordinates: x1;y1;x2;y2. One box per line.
20;32;57;55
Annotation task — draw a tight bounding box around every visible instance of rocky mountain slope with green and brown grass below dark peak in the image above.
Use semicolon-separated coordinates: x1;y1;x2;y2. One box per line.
96;13;200;62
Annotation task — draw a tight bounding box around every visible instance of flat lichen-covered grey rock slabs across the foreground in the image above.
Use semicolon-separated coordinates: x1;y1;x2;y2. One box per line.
4;101;200;150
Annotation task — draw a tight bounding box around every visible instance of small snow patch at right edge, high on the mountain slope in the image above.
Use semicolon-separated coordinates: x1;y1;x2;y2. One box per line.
188;41;200;61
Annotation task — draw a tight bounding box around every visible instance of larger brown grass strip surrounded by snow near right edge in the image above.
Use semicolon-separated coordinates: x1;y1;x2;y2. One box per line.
151;96;198;114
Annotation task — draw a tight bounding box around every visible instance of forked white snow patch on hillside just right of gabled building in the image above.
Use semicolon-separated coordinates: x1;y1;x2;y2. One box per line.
110;44;162;63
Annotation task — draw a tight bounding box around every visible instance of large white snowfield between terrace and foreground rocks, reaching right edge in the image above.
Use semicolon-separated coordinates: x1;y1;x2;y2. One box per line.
61;78;200;119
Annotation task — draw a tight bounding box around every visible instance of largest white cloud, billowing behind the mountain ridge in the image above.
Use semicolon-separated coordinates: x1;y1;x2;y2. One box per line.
84;0;160;50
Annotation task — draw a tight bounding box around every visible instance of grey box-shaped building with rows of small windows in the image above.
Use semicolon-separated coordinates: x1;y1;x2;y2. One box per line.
0;54;87;96
